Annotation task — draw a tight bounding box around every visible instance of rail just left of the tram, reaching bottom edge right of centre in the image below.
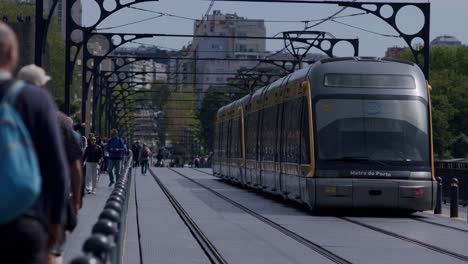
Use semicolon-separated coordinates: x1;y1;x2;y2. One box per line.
170;169;352;264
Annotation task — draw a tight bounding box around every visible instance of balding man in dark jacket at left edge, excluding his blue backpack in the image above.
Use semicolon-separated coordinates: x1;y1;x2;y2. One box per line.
0;22;69;264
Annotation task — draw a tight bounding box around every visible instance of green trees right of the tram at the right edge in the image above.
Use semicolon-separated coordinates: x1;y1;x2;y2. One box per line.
401;46;468;159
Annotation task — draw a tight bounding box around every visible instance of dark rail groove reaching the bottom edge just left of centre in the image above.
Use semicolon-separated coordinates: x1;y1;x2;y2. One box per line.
149;169;228;264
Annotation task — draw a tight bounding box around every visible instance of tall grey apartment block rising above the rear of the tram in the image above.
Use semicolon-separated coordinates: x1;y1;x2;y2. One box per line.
184;10;266;102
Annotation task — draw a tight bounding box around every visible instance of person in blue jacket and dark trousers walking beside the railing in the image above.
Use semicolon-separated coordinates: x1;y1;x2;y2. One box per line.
106;128;126;187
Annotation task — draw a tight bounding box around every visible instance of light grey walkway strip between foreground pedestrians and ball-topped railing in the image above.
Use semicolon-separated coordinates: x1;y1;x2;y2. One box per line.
63;173;114;263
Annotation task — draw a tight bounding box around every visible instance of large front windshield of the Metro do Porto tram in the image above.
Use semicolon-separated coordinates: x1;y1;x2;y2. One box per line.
315;99;430;167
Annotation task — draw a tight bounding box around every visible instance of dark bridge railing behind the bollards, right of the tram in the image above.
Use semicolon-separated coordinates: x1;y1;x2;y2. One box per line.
435;161;468;205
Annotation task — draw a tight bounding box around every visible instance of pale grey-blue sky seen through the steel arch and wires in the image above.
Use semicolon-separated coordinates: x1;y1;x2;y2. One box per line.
81;0;468;56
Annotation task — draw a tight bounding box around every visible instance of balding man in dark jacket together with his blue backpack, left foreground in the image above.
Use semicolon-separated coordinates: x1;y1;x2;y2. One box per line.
0;23;69;263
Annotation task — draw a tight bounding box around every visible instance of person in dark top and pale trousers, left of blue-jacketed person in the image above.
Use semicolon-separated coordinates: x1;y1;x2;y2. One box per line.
83;137;103;194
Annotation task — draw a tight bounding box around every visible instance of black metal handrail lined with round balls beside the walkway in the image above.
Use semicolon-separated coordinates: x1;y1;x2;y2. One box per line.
70;151;133;264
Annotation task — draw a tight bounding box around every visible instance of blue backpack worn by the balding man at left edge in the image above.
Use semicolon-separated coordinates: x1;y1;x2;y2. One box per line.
0;81;41;224
